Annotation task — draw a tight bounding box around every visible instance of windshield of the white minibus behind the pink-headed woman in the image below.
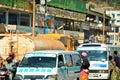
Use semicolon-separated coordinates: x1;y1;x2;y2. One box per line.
78;50;107;61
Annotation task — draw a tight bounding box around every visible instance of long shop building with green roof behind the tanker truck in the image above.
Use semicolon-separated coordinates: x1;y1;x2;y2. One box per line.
0;0;109;41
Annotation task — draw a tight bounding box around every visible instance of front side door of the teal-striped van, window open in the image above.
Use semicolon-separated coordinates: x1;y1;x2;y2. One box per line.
58;55;68;80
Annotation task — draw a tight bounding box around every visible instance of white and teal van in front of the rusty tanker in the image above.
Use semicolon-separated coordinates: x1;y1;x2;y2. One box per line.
14;50;80;80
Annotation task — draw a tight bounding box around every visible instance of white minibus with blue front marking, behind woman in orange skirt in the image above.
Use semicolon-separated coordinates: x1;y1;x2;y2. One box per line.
76;43;120;80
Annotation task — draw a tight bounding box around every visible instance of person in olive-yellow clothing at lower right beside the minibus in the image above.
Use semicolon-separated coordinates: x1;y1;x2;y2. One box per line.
109;56;119;80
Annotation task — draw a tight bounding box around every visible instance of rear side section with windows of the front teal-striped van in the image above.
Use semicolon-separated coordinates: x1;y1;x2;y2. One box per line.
65;53;80;80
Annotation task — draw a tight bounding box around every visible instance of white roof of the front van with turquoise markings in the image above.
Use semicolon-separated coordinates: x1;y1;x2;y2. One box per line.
26;50;79;54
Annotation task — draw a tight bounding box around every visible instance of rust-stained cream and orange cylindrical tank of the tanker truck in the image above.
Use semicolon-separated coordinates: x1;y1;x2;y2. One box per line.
0;34;65;60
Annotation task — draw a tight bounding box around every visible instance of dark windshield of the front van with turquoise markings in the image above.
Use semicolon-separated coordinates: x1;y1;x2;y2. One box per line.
19;56;56;68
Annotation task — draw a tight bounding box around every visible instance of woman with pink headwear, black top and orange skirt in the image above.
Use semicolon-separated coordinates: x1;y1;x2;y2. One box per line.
79;52;90;80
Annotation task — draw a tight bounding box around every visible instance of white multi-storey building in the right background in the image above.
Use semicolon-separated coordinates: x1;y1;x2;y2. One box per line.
109;10;120;45
